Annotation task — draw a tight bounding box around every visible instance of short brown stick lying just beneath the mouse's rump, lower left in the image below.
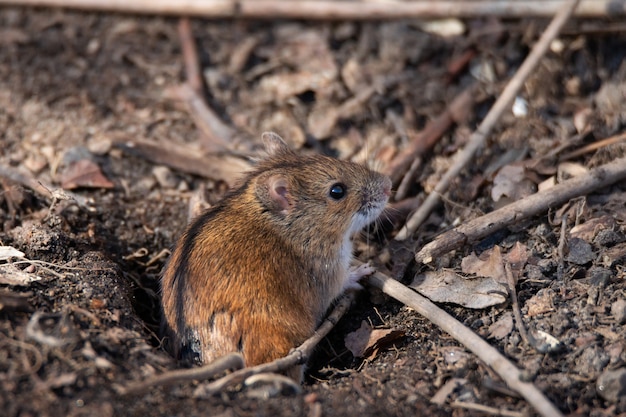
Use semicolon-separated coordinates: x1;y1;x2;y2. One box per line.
114;353;244;395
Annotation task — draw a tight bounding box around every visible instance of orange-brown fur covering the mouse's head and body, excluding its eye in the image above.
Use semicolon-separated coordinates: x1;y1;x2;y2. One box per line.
162;134;390;374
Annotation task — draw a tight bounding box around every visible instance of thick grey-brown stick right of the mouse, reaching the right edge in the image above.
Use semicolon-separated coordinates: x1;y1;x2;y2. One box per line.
415;157;626;263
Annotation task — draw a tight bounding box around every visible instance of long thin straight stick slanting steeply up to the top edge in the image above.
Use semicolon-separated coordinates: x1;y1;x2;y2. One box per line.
395;0;580;240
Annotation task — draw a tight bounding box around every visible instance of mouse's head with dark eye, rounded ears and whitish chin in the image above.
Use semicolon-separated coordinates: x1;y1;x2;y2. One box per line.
250;133;391;244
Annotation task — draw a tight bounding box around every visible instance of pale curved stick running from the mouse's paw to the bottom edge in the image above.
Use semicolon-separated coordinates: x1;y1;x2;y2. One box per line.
356;262;562;417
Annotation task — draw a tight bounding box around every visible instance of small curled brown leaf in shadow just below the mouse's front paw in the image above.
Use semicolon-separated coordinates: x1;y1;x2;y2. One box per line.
345;320;405;360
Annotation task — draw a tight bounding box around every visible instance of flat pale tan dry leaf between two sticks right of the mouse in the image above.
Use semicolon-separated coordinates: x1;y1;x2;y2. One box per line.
410;270;508;309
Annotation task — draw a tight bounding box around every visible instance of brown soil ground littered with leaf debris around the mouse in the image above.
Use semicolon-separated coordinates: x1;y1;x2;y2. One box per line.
0;7;626;417
